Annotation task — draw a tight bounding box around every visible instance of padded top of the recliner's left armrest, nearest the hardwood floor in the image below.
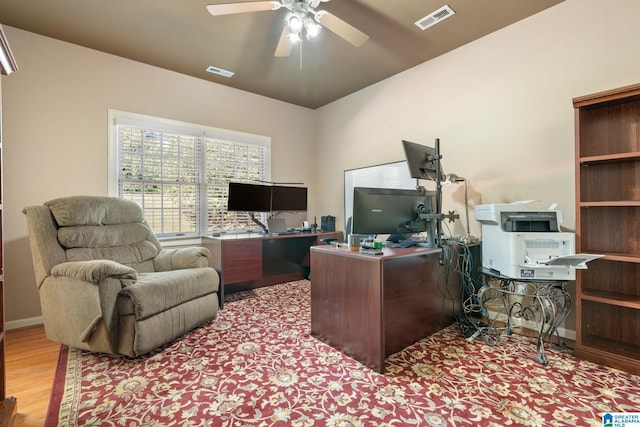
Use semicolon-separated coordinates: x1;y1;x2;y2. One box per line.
51;260;138;285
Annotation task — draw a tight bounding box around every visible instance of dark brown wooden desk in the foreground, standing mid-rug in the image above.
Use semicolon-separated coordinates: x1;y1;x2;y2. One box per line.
311;246;461;373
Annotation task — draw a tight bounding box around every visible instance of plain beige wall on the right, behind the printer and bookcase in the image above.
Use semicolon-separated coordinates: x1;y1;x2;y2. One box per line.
316;0;640;236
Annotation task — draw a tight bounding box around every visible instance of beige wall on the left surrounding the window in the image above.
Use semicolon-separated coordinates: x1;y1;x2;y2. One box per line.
2;27;315;327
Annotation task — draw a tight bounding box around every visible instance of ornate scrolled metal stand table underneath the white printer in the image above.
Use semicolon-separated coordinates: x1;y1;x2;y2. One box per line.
476;268;571;365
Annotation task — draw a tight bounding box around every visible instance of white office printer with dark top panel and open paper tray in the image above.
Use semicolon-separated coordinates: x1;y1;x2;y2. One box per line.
475;201;599;281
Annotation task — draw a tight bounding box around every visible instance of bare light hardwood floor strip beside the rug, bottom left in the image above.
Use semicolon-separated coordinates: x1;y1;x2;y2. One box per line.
5;326;60;427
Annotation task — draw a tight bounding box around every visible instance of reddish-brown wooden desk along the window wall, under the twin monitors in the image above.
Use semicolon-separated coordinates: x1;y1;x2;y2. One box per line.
208;232;343;295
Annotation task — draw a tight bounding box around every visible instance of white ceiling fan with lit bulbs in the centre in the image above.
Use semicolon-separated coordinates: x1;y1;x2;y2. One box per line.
207;0;369;56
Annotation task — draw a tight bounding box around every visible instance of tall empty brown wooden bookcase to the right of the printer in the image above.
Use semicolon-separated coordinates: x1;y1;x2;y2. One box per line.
573;84;640;374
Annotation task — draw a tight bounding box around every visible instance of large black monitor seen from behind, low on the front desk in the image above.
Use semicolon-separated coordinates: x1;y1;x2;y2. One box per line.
352;187;436;234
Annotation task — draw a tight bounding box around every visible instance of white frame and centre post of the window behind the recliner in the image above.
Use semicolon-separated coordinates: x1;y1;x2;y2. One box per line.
108;109;271;240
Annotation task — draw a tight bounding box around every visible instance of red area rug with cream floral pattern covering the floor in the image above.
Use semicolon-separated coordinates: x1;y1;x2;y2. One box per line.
46;280;640;427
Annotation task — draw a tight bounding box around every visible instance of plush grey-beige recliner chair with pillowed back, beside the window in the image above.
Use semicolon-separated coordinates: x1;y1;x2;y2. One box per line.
23;196;220;357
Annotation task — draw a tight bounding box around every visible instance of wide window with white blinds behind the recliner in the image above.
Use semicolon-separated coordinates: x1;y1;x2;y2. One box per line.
109;111;271;237
